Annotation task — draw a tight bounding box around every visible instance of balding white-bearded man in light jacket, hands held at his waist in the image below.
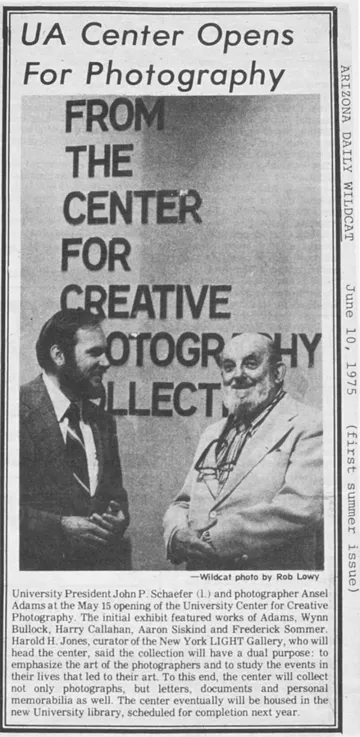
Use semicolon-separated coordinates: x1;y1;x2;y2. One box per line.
164;333;323;570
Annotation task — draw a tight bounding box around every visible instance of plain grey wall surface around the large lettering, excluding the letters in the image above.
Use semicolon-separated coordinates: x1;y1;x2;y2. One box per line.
21;95;321;569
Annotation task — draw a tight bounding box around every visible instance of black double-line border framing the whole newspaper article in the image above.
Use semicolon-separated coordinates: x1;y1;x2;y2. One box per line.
0;4;343;735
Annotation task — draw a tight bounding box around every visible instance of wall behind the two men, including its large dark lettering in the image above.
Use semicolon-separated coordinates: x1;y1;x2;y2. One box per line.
21;95;321;569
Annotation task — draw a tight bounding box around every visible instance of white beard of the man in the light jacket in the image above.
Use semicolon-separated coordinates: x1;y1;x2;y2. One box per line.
222;377;276;420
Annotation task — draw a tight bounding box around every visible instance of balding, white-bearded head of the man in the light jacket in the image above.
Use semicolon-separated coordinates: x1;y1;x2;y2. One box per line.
220;333;285;420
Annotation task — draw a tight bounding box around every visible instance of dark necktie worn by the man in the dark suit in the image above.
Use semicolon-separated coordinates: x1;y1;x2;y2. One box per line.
65;402;90;494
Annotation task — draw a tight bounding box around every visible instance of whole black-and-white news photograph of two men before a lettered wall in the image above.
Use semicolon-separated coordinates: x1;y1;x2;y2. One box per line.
20;95;323;570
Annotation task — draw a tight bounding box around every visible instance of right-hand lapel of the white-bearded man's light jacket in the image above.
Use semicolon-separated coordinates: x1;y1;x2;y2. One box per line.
216;395;298;504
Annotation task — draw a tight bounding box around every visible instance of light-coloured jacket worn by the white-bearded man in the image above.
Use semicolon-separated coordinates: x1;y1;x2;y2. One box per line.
164;394;323;570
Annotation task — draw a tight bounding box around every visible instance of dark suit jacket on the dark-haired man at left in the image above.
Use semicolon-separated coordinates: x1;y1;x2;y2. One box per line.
20;376;130;570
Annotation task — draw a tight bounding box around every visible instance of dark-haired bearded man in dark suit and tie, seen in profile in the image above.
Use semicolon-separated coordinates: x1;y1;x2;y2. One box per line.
20;309;130;570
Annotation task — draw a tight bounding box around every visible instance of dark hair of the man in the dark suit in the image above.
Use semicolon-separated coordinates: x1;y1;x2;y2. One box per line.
36;307;102;371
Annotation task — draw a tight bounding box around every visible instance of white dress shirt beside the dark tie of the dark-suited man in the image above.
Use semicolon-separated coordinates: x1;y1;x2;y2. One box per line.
43;373;99;496
